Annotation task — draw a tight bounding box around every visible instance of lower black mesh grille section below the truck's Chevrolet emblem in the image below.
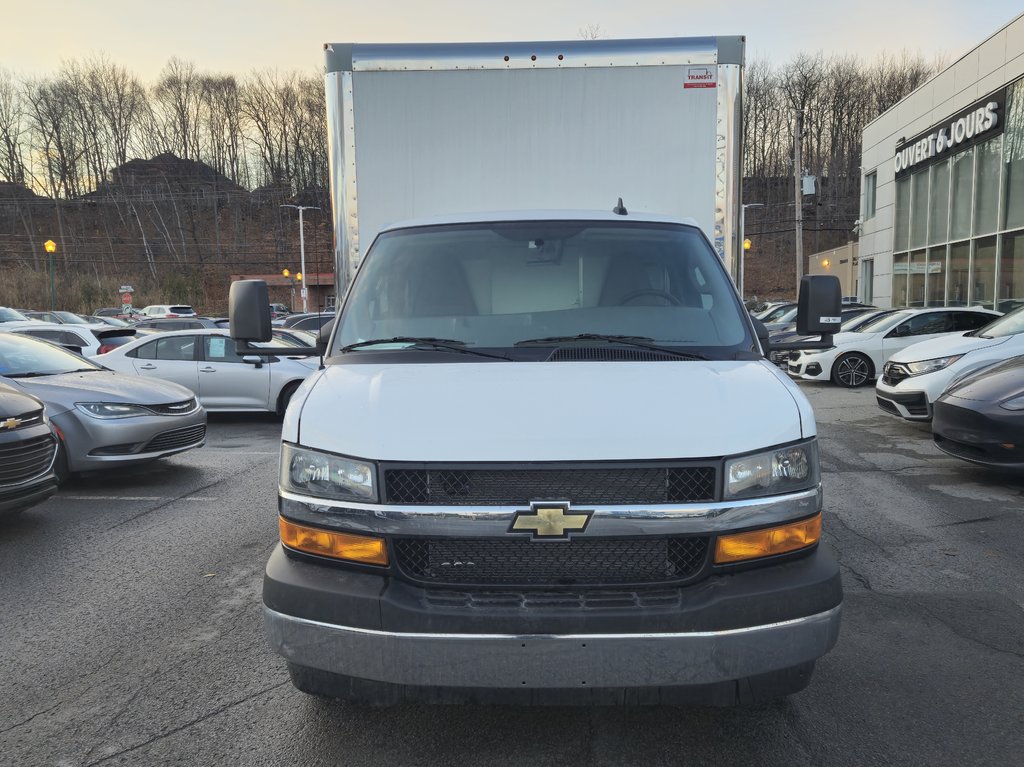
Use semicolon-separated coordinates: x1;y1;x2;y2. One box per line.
393;536;709;586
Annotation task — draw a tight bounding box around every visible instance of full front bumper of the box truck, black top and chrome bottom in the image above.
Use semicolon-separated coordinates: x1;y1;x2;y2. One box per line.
263;546;842;689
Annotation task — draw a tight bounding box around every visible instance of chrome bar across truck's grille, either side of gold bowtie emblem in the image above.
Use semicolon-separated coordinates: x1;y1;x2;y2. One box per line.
279;485;822;545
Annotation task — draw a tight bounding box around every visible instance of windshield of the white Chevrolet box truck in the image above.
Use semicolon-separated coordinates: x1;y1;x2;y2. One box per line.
334;221;752;358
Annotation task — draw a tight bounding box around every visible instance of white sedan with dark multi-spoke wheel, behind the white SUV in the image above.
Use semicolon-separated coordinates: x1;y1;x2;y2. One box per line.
788;306;999;388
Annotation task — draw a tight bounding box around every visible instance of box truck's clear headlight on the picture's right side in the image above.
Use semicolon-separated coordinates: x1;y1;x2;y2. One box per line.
725;439;821;499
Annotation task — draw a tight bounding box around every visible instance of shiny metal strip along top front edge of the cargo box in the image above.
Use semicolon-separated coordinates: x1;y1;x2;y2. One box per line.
337;37;718;72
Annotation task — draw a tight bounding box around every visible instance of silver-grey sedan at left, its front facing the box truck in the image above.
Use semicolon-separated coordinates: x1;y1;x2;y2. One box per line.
0;333;206;479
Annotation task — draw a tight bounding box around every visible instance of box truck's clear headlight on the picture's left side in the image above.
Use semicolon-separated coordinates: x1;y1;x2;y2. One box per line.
281;443;377;502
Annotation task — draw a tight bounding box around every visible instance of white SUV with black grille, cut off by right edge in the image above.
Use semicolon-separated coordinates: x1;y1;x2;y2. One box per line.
874;306;1024;421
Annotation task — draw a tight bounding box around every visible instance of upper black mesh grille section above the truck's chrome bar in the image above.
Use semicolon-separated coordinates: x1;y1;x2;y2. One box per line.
384;466;718;506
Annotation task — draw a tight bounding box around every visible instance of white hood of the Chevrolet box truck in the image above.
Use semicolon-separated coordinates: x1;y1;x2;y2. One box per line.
292;360;815;462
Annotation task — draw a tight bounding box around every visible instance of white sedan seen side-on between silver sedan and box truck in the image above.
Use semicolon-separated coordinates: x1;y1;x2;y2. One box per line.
96;330;317;414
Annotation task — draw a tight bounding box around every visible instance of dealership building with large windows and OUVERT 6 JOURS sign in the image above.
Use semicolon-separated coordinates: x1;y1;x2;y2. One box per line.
857;14;1024;311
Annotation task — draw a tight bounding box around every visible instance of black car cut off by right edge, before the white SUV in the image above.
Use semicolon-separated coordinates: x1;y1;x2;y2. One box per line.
932;356;1024;469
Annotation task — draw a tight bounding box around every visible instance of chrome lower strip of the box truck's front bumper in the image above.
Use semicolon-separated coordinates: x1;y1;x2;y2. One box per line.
263;606;841;688
